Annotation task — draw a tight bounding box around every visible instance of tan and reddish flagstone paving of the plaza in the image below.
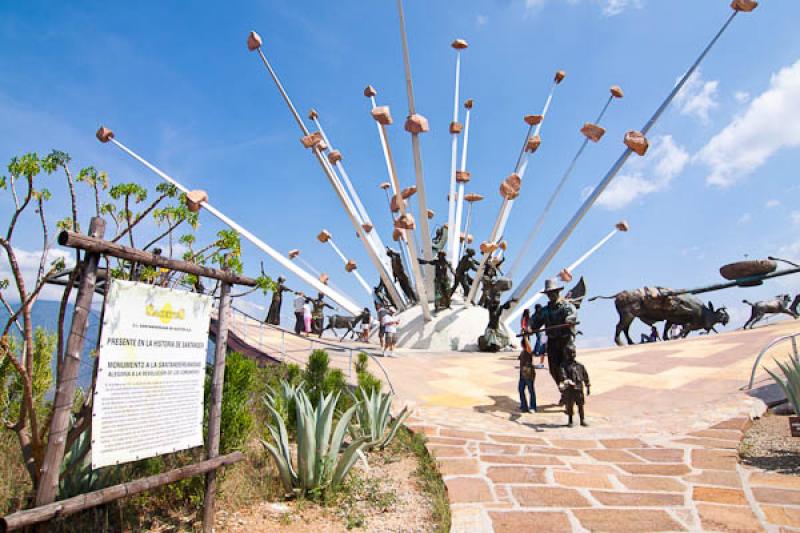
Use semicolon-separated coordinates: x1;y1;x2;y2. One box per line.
230;314;800;533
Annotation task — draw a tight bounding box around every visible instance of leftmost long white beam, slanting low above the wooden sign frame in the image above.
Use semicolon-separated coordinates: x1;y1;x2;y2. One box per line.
104;138;362;315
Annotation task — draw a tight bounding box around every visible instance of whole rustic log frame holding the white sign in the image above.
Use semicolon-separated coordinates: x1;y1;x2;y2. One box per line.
9;217;257;532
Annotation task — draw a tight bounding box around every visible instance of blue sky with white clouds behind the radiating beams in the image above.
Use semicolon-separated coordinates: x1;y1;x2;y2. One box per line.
0;0;800;345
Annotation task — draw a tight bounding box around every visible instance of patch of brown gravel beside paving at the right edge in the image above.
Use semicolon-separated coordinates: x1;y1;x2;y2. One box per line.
739;412;800;475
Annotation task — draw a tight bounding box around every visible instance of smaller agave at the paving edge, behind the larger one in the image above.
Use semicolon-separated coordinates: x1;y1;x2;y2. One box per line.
354;387;409;450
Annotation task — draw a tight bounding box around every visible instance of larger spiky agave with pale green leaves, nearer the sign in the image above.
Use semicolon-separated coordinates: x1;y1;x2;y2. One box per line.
261;389;366;494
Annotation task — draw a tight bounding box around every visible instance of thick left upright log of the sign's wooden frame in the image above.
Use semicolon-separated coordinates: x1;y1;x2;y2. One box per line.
36;217;106;507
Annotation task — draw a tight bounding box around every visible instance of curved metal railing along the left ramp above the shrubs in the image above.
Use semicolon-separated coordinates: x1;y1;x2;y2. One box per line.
222;307;395;394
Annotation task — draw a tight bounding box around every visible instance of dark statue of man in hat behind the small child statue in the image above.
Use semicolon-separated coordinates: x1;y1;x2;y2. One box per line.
528;279;578;394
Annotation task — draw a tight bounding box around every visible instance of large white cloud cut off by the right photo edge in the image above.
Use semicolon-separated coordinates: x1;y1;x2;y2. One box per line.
695;57;800;187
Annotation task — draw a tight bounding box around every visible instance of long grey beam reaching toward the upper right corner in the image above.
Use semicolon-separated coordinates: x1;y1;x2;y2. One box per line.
507;11;739;313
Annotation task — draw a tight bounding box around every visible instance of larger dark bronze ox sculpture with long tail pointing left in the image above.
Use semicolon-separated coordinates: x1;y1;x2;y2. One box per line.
589;287;730;346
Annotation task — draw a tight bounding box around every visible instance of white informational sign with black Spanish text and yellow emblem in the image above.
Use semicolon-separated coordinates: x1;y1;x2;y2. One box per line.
92;280;212;468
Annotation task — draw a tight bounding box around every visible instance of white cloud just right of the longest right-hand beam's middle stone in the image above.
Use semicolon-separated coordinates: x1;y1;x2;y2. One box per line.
597;135;689;210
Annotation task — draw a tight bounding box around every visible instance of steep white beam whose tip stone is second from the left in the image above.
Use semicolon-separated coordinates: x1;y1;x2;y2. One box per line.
248;36;403;314
